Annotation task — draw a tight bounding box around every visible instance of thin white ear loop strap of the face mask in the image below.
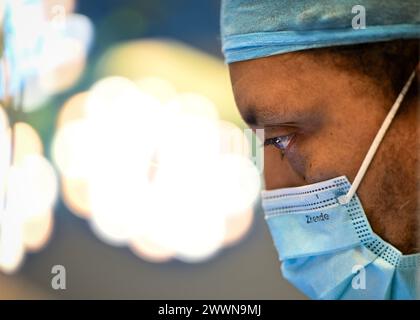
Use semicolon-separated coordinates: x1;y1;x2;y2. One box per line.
337;65;420;205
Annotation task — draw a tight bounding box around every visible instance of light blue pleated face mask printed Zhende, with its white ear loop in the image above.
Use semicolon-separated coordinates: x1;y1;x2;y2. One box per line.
262;66;420;299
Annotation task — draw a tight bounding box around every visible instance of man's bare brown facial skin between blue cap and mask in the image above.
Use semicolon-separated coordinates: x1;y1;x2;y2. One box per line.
229;50;420;254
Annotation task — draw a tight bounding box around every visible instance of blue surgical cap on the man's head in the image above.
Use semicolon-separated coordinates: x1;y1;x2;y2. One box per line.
221;0;420;63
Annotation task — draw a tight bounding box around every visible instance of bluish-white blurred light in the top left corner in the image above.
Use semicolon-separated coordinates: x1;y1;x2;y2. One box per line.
0;0;93;111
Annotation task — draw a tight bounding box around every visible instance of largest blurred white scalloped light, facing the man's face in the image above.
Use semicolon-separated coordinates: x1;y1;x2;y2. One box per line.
52;72;260;262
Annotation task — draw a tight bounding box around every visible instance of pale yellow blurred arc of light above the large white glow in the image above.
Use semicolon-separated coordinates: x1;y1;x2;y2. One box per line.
96;39;245;127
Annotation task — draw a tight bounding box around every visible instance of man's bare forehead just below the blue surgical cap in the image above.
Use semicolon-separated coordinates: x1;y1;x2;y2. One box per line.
229;53;334;123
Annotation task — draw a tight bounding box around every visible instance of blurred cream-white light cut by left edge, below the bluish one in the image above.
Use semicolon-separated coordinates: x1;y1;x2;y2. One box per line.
0;109;58;273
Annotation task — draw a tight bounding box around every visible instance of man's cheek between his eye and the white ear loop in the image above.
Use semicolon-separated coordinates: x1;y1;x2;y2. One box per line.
288;96;386;184
